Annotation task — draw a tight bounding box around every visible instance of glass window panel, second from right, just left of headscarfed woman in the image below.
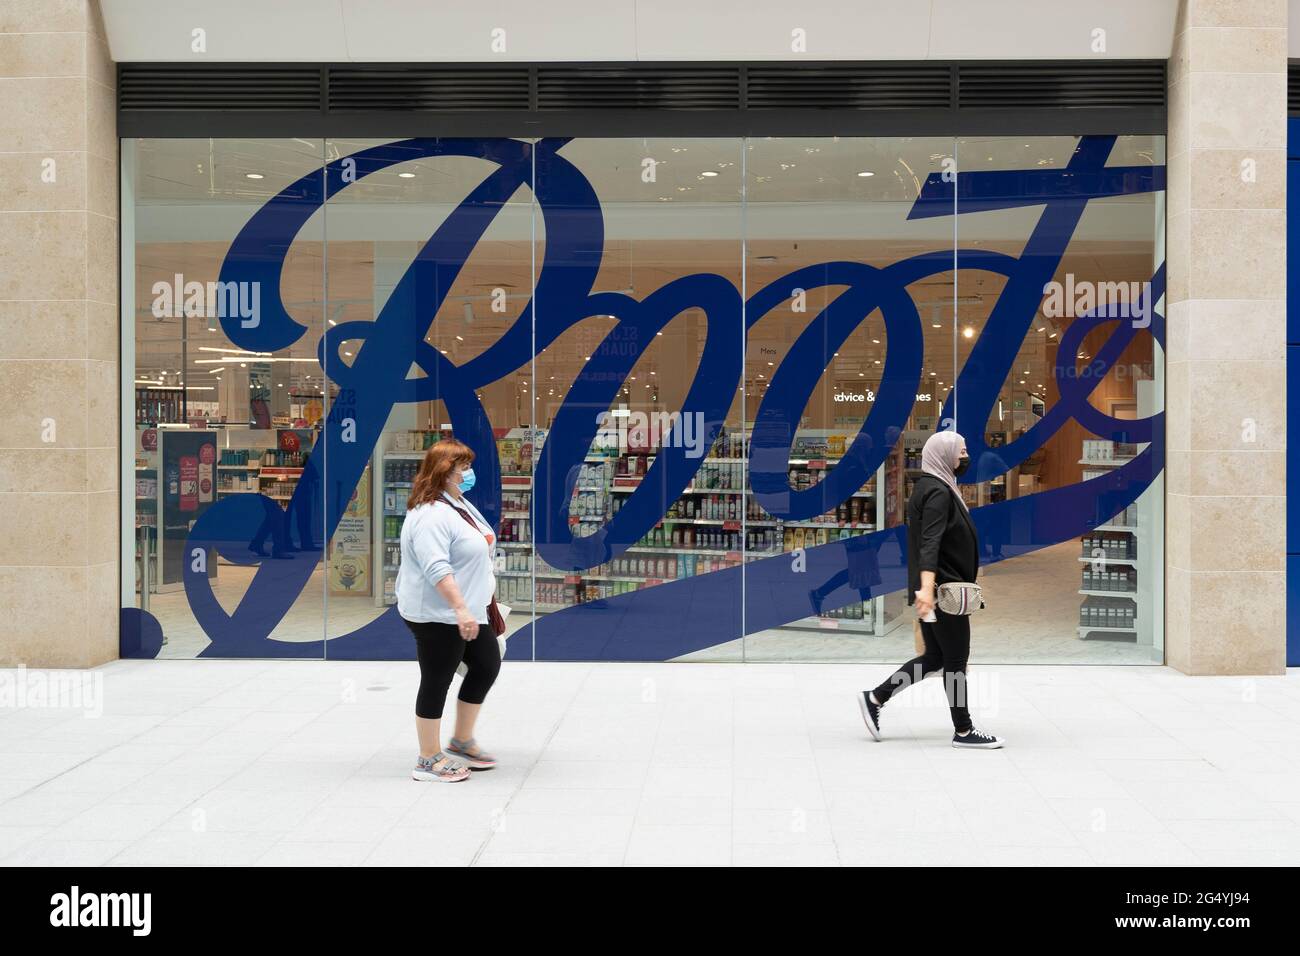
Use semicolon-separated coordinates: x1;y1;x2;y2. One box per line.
745;137;953;659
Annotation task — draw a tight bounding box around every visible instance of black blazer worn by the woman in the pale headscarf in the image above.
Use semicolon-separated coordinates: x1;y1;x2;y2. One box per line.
907;475;979;604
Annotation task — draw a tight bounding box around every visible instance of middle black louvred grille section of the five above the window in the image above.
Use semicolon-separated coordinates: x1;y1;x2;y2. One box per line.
536;65;741;109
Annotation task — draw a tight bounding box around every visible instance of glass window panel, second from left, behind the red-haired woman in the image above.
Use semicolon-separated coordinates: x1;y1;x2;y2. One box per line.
325;139;533;658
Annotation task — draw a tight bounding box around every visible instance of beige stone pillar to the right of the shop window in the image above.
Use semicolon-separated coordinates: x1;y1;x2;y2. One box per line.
1165;0;1287;674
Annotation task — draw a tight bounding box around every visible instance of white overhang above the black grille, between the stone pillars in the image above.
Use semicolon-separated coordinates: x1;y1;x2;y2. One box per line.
101;0;1178;62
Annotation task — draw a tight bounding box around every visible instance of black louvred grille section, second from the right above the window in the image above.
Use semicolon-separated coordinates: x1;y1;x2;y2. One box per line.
745;64;953;109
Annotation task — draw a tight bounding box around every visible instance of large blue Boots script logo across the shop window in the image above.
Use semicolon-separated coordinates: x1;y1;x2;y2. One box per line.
122;137;1165;659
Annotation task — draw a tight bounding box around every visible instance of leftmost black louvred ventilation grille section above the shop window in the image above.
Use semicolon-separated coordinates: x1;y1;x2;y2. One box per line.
117;64;321;111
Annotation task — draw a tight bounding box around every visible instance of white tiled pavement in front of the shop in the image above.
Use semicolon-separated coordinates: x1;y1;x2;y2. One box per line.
0;661;1300;866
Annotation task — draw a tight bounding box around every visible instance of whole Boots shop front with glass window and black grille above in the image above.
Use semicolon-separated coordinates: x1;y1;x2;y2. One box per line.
118;61;1166;663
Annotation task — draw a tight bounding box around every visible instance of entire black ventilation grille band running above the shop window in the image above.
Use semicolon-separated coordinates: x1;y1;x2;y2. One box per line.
117;60;1170;137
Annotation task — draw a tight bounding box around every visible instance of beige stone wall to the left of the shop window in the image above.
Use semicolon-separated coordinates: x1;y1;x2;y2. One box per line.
0;0;120;667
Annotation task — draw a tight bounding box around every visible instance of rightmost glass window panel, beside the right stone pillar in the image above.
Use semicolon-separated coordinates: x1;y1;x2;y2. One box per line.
949;137;1165;663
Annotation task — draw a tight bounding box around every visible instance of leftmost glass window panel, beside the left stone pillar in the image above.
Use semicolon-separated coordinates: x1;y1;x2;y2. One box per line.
122;139;325;657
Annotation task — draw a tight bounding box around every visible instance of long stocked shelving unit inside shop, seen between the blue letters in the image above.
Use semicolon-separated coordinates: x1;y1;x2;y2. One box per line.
374;428;884;633
